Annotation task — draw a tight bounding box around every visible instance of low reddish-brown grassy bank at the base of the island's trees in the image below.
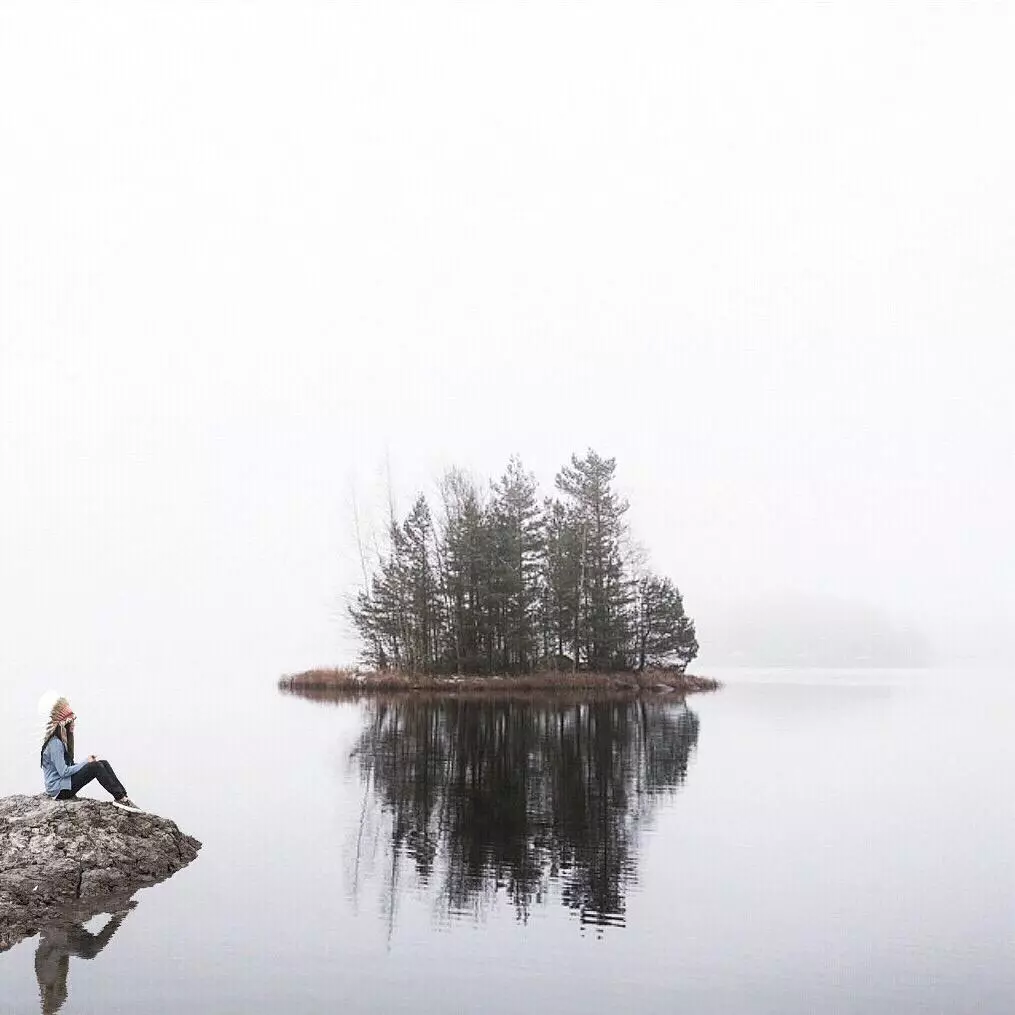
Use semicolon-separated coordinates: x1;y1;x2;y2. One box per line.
278;668;722;697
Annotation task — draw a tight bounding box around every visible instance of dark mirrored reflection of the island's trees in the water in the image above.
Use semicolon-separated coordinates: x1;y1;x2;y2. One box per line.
353;697;698;926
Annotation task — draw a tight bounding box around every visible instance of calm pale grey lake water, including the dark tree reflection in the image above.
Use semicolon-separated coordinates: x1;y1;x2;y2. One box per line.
0;671;1015;1015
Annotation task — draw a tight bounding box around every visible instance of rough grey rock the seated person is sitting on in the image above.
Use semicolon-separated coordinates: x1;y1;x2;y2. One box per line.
0;795;201;951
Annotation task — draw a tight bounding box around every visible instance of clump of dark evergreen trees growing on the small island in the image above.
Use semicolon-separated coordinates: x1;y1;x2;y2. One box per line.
350;451;698;674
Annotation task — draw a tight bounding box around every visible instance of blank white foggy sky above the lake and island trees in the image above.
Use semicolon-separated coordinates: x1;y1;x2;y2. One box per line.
0;0;1015;685
